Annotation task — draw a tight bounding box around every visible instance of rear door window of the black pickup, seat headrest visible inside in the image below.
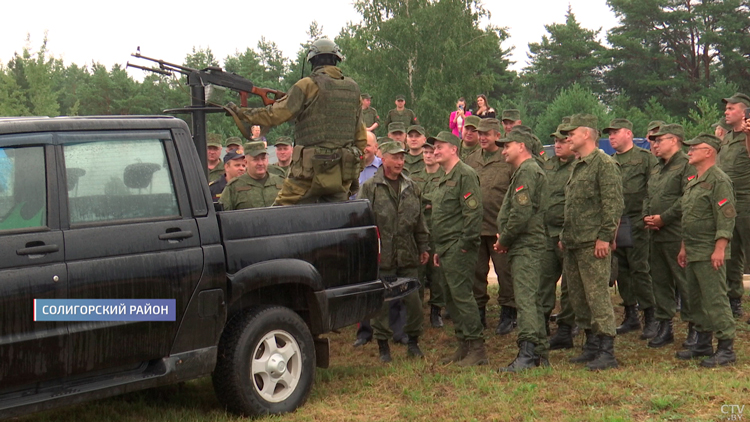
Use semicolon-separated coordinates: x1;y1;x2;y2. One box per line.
63;139;180;224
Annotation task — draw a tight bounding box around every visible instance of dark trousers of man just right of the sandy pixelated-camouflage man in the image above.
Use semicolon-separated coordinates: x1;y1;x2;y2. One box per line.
613;217;654;310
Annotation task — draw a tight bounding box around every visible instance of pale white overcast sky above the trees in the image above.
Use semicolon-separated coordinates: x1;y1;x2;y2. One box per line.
0;0;617;79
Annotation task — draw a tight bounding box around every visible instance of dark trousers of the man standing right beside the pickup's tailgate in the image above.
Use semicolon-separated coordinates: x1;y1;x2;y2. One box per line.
370;267;424;340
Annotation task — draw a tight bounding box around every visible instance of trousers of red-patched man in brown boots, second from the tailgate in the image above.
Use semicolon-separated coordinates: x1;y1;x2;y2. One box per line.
439;243;483;340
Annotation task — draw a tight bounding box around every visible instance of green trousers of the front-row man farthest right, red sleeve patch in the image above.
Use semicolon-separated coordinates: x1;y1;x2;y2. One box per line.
686;261;736;340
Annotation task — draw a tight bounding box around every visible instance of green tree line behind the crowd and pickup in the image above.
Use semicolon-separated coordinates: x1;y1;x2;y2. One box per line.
0;0;750;142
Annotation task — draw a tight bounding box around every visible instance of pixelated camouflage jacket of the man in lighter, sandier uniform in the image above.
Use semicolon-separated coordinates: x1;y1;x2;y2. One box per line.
560;148;625;248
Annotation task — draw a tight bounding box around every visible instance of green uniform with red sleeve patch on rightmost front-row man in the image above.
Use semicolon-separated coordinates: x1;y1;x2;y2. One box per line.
682;166;737;340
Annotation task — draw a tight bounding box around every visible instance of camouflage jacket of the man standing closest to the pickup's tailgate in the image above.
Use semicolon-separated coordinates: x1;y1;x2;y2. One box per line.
357;166;430;270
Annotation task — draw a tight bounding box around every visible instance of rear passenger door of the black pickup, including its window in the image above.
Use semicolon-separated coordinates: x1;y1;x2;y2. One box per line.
59;130;203;375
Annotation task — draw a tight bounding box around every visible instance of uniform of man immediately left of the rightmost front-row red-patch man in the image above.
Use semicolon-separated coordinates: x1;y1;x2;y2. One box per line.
643;150;695;322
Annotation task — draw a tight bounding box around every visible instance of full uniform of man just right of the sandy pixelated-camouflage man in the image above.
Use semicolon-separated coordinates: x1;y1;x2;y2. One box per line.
612;145;657;311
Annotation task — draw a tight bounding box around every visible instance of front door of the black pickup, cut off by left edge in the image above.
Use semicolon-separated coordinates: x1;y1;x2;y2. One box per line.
0;143;68;393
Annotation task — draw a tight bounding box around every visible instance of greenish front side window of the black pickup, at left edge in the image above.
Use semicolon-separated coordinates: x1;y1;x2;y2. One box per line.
0;147;47;230
